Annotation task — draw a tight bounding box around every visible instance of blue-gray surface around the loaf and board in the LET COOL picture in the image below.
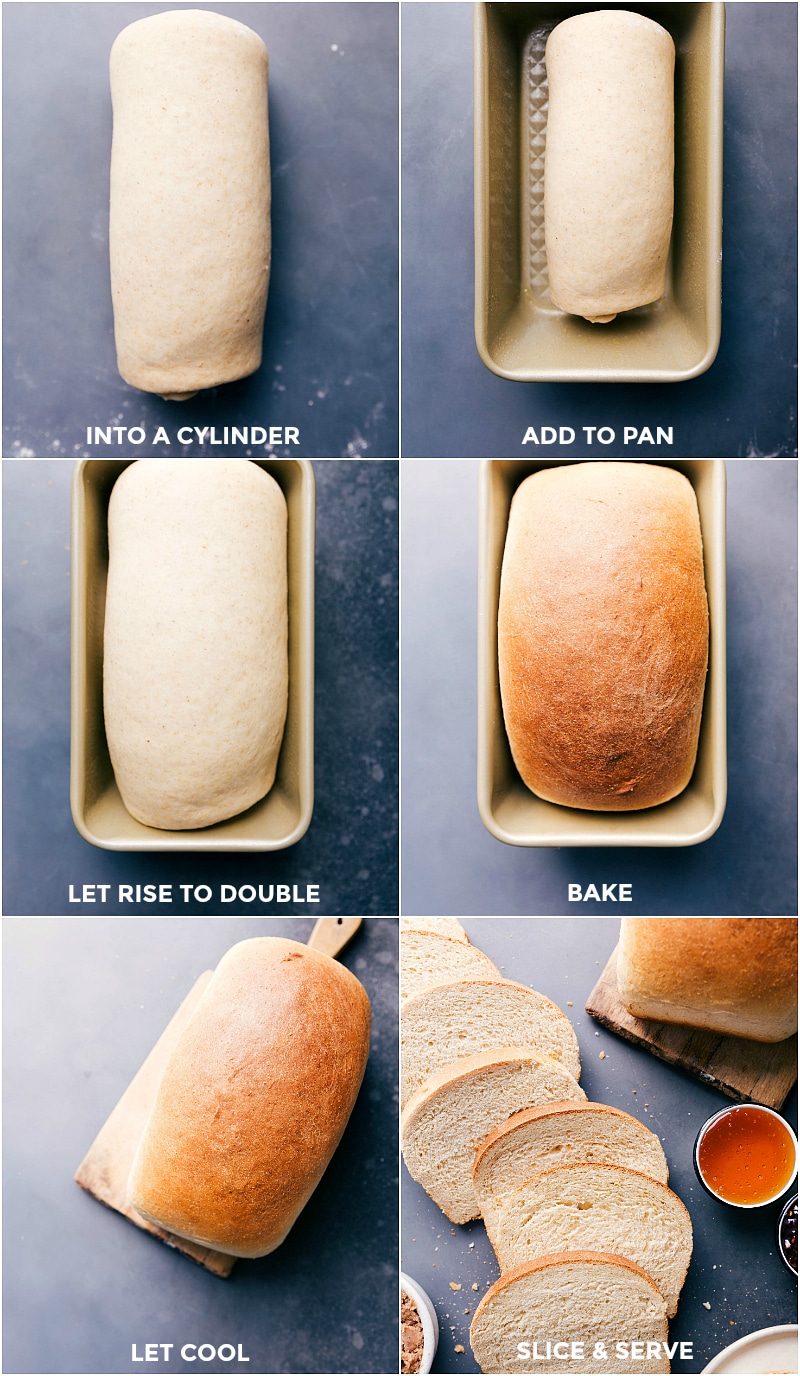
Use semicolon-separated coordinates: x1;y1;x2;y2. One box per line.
3;918;398;1376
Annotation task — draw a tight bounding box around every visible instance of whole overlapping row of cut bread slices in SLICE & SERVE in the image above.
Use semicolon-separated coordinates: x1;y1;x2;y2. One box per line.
401;918;691;1373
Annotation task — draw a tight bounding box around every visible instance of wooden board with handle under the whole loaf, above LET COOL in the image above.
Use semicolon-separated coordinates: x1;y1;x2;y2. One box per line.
74;918;362;1277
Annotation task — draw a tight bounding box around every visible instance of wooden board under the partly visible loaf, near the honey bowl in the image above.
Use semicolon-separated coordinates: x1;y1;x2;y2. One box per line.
587;948;797;1109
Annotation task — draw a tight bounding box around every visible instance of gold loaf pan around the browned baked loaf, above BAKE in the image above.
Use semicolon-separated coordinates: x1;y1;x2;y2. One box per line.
478;458;727;846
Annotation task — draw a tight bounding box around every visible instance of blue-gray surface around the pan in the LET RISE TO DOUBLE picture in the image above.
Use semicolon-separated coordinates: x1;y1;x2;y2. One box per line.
3;458;398;915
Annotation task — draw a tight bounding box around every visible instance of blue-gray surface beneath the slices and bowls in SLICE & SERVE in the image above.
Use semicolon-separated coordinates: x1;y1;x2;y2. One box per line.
402;918;797;1373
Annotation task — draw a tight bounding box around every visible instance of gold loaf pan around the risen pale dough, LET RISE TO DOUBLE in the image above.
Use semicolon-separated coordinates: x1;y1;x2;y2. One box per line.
70;458;314;850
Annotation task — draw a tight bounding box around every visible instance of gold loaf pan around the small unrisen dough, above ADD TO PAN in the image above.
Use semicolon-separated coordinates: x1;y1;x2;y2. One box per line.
474;3;724;383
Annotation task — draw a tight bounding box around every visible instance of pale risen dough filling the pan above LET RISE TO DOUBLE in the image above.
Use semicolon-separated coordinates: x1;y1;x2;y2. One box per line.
103;458;288;831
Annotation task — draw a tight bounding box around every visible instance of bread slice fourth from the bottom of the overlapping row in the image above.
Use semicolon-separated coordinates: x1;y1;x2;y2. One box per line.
401;1047;585;1223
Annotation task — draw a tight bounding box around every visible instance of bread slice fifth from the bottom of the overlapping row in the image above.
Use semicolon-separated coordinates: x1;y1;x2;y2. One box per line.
401;980;581;1106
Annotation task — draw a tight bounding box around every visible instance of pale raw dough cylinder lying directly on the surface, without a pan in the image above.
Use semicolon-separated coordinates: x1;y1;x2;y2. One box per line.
109;10;270;400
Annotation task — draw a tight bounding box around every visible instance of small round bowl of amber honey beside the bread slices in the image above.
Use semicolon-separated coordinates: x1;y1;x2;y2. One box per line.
694;1104;797;1208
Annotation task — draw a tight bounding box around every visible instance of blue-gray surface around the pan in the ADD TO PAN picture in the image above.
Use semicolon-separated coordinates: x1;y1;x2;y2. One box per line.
402;3;797;458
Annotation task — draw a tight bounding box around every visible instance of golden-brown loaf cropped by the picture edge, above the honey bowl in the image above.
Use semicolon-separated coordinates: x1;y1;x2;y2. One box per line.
617;918;797;1042
